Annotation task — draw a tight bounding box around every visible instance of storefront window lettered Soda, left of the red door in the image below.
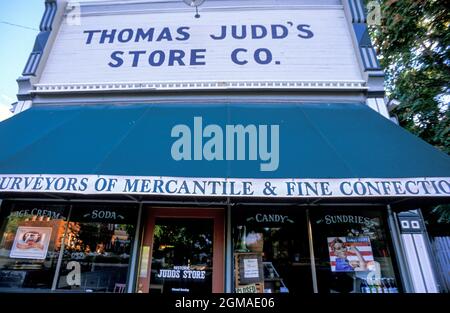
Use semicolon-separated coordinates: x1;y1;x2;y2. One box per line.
58;205;136;292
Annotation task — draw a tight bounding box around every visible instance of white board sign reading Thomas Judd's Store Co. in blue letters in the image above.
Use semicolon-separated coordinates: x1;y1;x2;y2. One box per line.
39;8;362;88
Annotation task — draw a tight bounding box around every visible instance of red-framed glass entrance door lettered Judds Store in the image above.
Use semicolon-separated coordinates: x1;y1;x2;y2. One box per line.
135;208;224;293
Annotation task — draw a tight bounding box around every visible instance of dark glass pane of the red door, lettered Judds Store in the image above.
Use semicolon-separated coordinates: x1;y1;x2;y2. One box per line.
150;218;213;293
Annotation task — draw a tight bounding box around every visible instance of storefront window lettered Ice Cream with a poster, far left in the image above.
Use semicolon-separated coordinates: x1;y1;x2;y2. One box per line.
0;203;68;290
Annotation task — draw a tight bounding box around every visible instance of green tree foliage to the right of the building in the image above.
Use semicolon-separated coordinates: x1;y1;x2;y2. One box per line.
371;0;450;153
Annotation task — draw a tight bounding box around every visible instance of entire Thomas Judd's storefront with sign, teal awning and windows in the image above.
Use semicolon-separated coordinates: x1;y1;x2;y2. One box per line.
0;0;450;294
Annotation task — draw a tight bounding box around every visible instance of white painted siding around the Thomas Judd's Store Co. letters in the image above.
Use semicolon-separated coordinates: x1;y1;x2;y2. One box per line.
39;8;362;88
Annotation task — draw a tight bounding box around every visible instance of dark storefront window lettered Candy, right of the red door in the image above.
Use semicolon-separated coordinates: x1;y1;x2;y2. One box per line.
233;208;312;294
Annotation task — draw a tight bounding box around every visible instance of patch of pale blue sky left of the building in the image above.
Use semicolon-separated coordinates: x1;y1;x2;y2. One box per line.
0;0;45;121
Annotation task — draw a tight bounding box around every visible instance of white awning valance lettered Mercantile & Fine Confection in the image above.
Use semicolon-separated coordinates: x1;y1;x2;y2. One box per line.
0;175;450;198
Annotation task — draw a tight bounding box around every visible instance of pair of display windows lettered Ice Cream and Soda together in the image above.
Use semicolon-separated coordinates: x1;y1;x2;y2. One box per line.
0;202;137;292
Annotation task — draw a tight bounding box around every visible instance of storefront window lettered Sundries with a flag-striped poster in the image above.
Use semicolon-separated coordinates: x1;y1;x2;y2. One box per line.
310;208;399;293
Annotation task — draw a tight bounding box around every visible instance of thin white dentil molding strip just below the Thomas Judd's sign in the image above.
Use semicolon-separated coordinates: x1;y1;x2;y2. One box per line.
32;81;367;94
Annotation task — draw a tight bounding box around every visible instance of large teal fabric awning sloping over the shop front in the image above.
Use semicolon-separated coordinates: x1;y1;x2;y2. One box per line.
0;103;450;196
